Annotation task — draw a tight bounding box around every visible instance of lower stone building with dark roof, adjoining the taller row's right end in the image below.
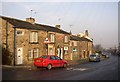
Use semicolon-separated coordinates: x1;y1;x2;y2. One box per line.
70;31;93;60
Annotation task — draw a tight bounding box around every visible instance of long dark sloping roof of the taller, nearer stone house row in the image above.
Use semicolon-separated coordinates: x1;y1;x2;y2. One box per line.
0;16;69;34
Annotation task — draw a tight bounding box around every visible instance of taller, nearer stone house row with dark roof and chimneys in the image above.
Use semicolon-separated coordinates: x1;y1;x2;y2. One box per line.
0;16;70;65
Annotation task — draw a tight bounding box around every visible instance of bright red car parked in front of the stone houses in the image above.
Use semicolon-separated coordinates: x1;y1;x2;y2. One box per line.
34;55;68;69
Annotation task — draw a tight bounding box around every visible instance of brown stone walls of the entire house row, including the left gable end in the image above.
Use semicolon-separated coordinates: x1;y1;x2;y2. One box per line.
2;16;92;65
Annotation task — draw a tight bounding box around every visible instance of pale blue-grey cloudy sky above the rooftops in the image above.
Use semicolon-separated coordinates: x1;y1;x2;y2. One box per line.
1;0;118;48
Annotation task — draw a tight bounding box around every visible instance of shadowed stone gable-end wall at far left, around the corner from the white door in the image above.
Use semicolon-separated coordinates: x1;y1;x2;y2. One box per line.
0;18;14;64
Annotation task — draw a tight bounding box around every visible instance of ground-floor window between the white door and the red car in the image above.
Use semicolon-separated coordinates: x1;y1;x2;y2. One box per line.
28;48;39;60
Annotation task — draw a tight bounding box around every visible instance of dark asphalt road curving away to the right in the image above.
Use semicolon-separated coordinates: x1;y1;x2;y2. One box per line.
2;56;118;80
